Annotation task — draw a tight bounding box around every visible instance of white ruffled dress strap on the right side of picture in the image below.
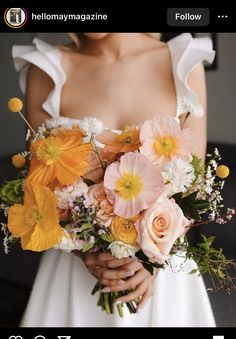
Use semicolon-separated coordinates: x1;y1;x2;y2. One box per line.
167;33;215;118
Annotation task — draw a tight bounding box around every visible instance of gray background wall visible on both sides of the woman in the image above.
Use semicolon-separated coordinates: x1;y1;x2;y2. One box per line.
0;33;236;155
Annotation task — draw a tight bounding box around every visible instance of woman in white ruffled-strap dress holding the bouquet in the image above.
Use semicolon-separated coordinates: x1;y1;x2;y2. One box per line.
13;33;215;327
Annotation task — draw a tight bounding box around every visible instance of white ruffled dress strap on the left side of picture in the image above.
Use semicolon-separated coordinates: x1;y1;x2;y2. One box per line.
12;38;66;118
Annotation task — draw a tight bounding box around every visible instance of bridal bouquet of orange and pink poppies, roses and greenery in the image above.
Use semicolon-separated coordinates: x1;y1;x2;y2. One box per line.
0;98;235;316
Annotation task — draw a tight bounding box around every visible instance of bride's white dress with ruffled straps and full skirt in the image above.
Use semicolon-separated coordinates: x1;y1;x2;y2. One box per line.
12;33;215;327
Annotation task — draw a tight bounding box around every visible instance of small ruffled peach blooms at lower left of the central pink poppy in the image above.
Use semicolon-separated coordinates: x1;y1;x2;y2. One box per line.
88;183;113;227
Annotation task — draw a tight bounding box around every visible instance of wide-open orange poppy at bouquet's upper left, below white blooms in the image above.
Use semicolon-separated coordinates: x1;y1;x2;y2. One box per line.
27;128;92;188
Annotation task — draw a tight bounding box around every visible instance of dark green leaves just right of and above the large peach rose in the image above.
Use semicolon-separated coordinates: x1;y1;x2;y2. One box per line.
172;191;210;221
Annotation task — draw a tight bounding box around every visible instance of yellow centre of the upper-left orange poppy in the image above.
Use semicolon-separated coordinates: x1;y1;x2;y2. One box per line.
37;137;62;165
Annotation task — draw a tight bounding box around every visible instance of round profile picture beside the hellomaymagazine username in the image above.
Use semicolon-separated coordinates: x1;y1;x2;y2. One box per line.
4;8;28;28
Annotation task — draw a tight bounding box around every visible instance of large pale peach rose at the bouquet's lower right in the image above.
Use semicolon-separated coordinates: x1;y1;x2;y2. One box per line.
136;199;189;264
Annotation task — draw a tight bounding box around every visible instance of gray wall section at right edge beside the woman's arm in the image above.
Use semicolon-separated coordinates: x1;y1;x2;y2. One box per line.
207;33;236;144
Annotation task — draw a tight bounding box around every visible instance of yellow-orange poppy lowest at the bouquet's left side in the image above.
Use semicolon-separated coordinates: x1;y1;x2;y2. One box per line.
7;183;64;252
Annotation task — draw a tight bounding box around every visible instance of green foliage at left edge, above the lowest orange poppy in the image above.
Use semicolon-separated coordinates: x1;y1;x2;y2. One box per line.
0;179;24;206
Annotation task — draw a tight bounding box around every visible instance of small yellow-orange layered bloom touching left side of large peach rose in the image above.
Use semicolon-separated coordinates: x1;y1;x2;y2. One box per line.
111;216;138;245
